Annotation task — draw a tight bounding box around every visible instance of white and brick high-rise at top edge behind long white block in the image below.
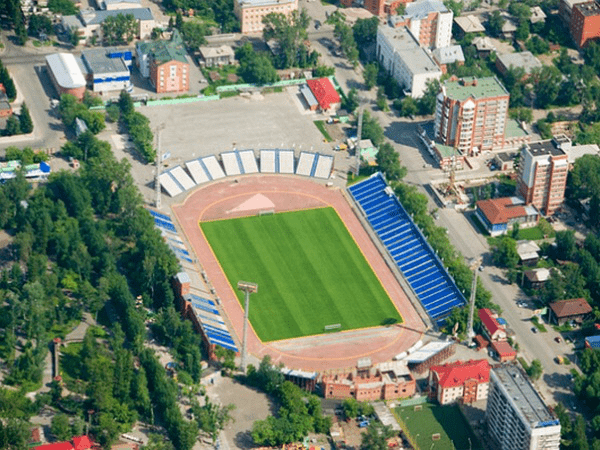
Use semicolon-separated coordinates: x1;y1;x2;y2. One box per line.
390;0;454;49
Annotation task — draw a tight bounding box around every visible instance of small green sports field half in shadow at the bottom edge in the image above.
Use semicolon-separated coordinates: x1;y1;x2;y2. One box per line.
395;403;483;450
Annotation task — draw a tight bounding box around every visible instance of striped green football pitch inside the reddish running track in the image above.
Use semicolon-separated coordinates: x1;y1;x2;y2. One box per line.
200;208;402;342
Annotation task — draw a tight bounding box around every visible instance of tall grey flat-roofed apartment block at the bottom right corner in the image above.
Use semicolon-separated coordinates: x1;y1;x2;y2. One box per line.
486;365;560;450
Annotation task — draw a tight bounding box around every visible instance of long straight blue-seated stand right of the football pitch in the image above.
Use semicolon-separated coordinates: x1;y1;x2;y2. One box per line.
348;173;466;325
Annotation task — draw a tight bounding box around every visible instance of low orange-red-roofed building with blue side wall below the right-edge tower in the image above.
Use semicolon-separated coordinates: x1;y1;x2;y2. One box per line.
475;197;540;236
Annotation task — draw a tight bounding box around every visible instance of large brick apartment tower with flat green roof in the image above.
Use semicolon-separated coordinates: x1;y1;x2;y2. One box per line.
434;77;510;156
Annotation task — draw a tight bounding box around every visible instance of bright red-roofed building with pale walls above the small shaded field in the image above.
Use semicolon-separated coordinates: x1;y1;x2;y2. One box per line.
429;359;490;405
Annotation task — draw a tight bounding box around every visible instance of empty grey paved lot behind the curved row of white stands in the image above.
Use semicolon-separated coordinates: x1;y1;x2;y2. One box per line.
114;88;347;202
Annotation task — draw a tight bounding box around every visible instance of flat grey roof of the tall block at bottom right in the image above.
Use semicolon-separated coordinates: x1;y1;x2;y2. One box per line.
491;365;560;428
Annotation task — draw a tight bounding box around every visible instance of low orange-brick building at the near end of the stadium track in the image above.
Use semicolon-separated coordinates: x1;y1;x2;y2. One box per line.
321;358;417;402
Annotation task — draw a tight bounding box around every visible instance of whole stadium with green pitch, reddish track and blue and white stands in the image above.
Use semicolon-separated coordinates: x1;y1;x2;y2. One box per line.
151;149;465;372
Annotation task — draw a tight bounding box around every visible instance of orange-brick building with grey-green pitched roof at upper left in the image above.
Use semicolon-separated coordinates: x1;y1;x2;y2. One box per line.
136;30;190;94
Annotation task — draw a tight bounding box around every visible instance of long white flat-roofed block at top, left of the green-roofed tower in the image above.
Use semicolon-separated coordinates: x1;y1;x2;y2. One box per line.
377;26;442;98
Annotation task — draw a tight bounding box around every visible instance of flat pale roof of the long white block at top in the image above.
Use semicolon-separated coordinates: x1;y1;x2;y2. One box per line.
377;26;441;74
